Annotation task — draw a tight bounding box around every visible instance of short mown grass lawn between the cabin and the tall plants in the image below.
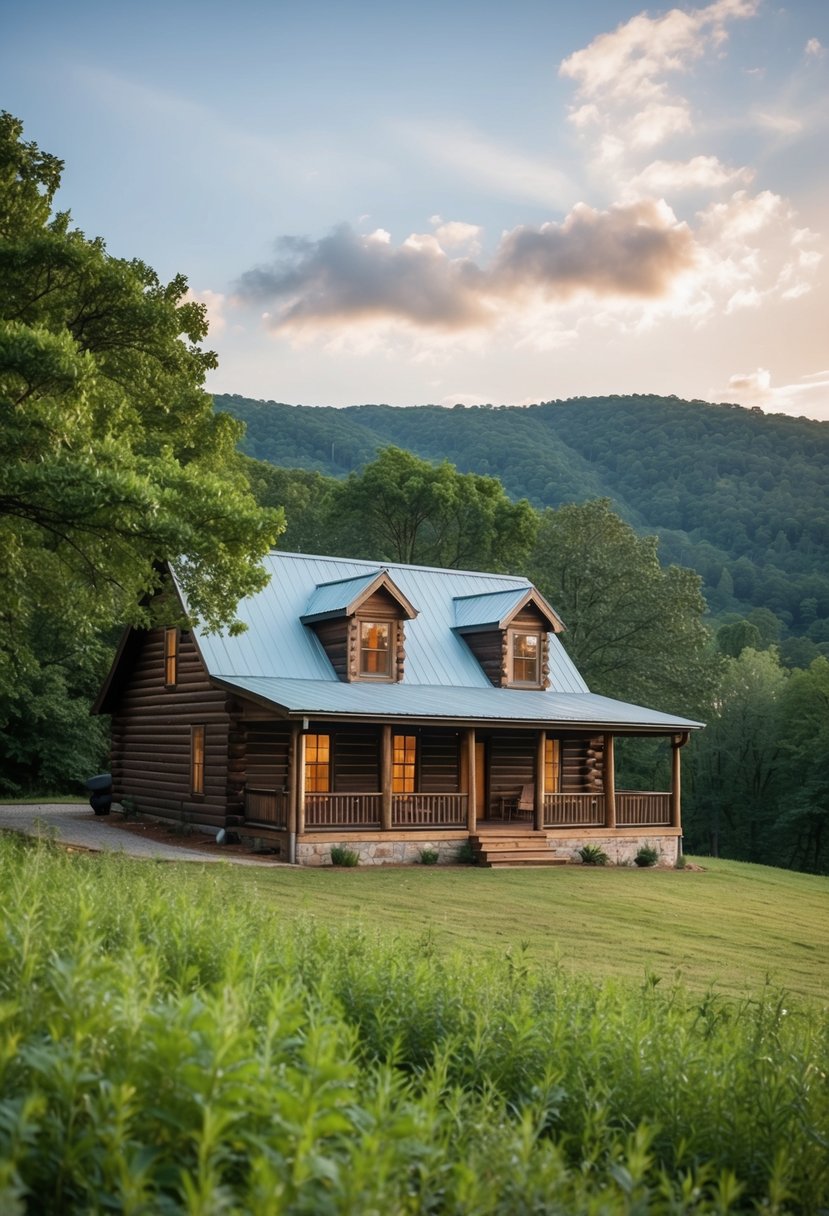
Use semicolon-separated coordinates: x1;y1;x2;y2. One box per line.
225;858;829;1004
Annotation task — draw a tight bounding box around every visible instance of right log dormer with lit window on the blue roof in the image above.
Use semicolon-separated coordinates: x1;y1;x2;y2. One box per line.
453;586;564;689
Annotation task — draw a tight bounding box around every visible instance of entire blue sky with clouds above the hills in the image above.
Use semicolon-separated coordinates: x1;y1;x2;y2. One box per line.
6;0;829;420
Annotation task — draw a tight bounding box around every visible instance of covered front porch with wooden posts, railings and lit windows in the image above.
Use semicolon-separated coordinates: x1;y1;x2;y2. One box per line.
236;719;688;860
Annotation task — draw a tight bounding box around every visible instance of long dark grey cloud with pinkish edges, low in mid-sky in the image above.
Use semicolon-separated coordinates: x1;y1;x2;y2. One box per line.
238;199;695;331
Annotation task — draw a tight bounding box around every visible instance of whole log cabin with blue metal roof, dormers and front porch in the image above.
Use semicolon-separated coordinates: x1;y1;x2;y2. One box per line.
94;552;701;866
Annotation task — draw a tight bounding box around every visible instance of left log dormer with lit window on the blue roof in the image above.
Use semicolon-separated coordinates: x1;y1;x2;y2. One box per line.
300;569;417;683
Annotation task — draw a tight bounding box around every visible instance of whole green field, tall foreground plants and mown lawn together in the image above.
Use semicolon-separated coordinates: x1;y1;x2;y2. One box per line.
0;835;829;1216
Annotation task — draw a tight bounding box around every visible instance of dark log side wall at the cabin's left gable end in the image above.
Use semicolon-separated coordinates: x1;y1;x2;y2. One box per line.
112;629;229;827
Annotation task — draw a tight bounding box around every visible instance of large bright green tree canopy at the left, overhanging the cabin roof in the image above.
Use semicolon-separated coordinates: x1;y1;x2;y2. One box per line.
0;114;281;695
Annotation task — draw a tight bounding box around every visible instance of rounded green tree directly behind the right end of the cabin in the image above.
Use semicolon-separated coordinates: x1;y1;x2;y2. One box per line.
531;499;715;713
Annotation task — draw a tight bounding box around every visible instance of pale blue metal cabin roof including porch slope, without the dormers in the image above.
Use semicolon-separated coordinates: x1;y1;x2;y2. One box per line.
190;552;699;730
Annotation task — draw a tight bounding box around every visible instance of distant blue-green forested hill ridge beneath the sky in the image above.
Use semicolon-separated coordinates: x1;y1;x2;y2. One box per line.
216;395;829;659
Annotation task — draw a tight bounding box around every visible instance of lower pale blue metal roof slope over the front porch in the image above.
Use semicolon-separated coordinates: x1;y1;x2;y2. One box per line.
214;672;703;732
